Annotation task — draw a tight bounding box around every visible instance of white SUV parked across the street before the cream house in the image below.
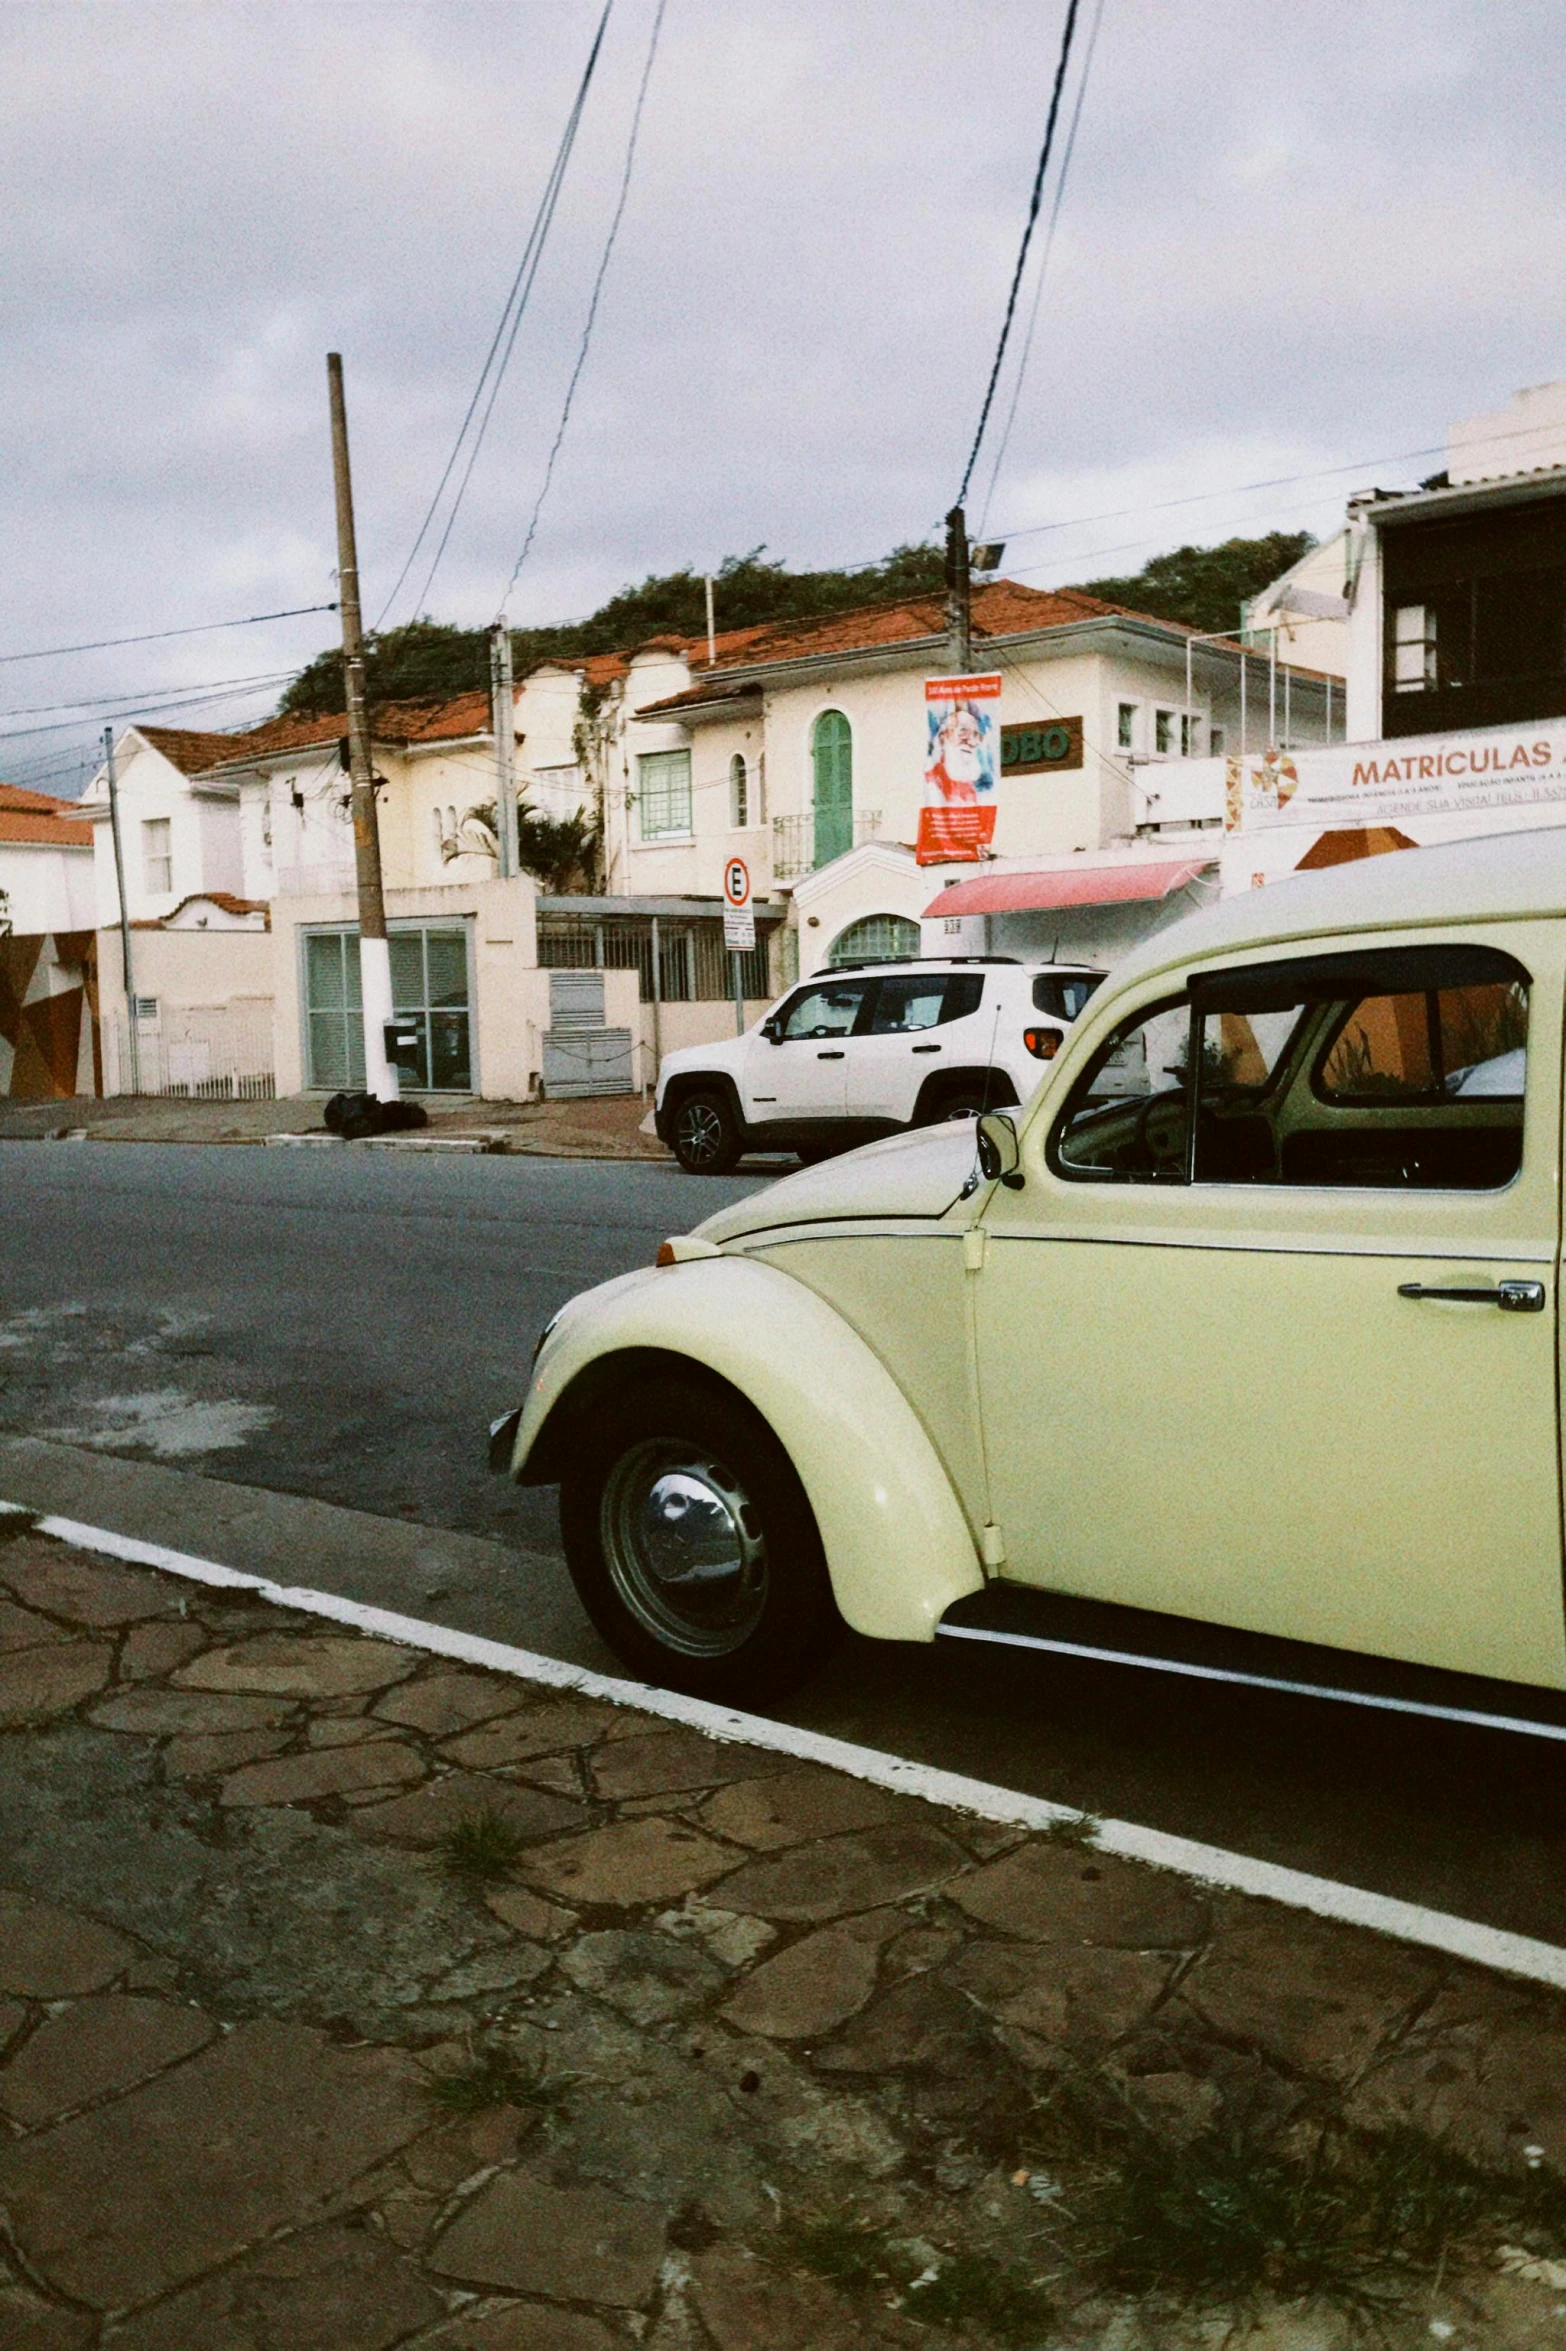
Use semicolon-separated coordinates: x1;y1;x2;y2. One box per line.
654;955;1103;1176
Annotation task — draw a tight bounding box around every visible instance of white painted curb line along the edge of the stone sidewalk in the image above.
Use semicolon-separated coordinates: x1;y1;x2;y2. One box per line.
18;1502;1566;1989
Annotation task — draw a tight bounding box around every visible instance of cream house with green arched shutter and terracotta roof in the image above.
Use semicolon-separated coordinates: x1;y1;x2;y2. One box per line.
600;581;1343;978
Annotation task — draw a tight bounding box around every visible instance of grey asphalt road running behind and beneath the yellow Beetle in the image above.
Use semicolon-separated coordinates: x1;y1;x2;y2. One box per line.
0;1143;1566;1942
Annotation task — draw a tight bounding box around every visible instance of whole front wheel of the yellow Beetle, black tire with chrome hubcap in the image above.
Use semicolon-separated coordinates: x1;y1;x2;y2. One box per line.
560;1375;839;1704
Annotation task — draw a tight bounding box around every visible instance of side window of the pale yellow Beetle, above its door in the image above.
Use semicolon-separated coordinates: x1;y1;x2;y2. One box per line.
1049;945;1528;1192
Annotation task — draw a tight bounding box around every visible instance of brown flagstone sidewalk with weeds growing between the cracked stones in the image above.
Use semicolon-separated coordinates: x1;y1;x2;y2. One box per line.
0;1521;1566;2351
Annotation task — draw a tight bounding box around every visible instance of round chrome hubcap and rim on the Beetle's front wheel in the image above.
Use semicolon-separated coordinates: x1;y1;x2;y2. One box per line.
602;1439;767;1657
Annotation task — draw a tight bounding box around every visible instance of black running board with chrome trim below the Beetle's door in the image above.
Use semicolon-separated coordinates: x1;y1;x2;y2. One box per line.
936;1582;1566;1744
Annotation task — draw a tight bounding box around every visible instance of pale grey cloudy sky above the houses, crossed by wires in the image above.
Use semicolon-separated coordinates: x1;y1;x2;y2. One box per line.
0;0;1566;792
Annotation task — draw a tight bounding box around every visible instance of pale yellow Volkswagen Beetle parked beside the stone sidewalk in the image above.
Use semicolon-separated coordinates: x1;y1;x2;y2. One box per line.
491;830;1566;1726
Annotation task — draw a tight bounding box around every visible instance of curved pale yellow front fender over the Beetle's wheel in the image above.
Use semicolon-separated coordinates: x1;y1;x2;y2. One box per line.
510;1255;983;1641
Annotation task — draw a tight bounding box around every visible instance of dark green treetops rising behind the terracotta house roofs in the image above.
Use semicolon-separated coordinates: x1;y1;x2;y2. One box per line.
277;531;1314;717
